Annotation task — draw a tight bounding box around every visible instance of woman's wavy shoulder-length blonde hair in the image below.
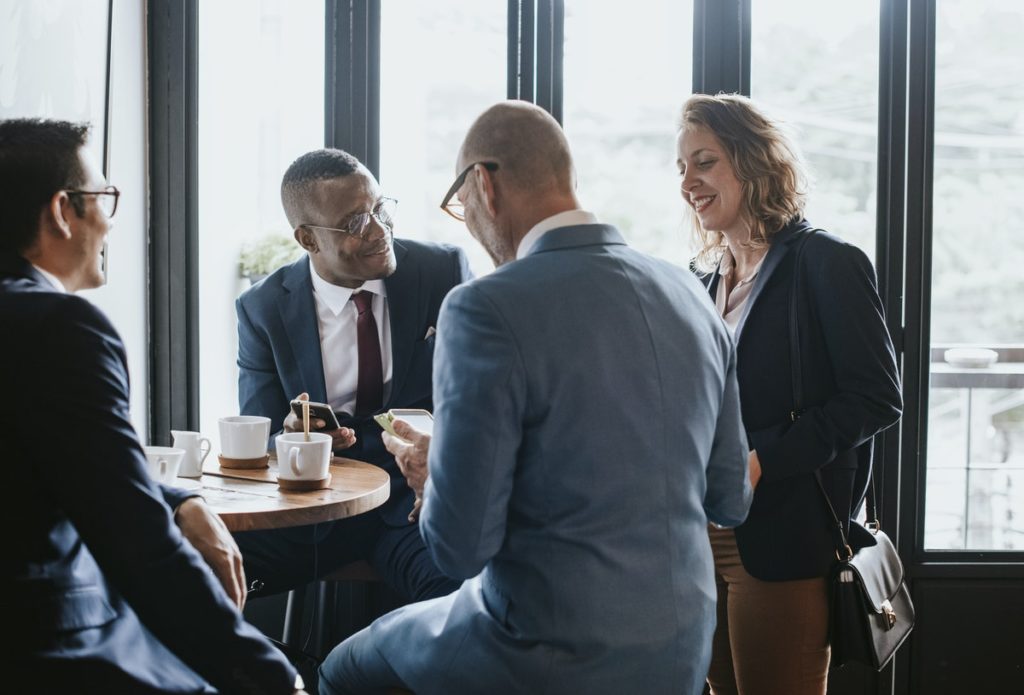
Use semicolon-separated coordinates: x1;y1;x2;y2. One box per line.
679;94;807;272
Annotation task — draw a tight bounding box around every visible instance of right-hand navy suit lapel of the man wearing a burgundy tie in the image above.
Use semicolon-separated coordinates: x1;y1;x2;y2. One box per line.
384;242;415;407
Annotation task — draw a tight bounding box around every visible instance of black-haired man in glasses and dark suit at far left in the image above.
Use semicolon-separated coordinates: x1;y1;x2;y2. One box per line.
0;120;298;694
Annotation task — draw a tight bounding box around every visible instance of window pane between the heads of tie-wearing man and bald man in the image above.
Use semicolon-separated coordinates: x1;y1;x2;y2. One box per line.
380;0;508;275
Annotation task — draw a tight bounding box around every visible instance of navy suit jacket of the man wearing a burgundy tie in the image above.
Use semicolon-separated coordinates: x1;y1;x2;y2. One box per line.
236;240;472;525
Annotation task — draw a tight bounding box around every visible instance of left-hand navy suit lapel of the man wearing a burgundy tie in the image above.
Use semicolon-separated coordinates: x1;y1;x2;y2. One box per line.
278;258;327;403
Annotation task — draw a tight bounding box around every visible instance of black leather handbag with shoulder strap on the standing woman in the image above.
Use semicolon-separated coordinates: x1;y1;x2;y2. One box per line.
790;229;914;670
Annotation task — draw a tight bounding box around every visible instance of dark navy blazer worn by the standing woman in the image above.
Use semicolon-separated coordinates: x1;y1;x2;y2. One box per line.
705;220;902;581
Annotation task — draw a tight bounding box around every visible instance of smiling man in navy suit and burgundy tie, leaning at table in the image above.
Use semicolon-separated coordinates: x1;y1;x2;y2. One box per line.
236;149;471;600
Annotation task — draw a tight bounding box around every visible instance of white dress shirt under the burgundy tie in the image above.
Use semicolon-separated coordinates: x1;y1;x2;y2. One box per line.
307;261;391;414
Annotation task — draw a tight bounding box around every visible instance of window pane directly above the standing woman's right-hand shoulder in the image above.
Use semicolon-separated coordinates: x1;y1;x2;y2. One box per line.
751;0;879;260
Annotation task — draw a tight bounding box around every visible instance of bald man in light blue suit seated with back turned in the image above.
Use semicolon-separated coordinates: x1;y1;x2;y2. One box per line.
321;102;752;695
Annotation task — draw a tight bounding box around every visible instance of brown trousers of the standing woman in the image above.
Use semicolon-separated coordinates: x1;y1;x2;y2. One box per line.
708;527;829;695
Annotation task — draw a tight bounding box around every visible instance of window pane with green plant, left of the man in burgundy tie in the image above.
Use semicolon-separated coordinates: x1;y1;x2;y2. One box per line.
192;0;324;448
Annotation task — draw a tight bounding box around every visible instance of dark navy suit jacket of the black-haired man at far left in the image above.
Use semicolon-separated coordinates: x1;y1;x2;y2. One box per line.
0;255;295;693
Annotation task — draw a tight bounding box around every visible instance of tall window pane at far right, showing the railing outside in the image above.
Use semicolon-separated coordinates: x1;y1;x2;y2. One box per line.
925;0;1024;550
